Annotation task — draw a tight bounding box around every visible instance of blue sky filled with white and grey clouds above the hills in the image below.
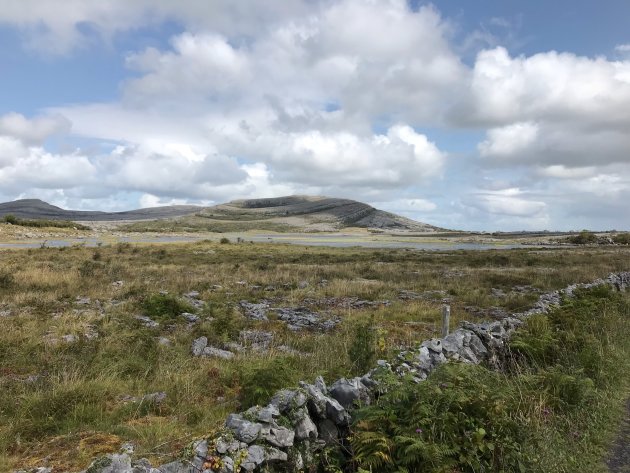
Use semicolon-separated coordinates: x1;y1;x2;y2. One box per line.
0;0;630;231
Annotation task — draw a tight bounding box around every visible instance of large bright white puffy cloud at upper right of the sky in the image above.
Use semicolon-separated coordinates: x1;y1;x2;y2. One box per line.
453;47;630;126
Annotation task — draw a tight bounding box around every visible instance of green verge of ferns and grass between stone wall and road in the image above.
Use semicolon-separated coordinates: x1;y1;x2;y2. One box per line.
351;288;630;473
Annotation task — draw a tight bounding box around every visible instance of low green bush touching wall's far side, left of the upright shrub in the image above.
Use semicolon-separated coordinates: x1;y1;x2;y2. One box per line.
239;356;299;408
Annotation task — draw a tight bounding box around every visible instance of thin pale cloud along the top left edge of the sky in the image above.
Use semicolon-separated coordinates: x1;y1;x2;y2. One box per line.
0;0;312;55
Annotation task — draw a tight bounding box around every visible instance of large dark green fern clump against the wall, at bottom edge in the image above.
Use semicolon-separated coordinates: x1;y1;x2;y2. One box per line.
352;364;525;472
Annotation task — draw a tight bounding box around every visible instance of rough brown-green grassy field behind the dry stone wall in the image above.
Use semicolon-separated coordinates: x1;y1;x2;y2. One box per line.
0;234;630;471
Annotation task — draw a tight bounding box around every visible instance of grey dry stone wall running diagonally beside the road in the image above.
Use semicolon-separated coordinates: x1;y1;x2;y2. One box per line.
22;272;630;473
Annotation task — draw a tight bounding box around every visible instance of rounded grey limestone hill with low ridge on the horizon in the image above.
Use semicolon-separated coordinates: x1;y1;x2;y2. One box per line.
0;195;441;233
